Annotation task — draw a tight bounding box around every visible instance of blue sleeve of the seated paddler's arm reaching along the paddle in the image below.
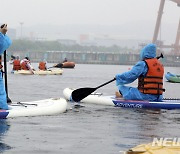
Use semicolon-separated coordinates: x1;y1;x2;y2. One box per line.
116;61;148;86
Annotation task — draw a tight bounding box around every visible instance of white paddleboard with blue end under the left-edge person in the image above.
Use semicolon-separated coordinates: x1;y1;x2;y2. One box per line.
0;98;67;119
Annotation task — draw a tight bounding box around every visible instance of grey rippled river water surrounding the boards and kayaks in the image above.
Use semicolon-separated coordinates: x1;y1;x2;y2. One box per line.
0;63;180;154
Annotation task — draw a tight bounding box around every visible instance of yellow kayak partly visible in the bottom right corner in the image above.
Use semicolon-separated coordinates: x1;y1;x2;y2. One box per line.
126;141;180;154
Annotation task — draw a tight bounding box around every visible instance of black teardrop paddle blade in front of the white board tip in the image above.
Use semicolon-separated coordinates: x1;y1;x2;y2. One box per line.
71;88;97;102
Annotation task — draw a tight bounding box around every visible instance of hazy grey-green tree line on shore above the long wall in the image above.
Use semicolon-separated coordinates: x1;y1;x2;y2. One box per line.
8;39;135;53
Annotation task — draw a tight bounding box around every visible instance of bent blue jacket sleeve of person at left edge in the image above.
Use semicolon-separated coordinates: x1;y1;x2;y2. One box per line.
0;32;12;54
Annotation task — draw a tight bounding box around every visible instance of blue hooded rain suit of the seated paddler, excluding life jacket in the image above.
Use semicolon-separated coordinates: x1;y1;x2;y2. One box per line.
116;44;163;101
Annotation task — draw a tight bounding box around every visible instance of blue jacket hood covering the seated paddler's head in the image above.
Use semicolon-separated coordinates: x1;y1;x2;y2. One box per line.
140;44;156;60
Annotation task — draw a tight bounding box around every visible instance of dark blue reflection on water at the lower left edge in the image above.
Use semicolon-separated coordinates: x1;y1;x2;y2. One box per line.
0;119;11;153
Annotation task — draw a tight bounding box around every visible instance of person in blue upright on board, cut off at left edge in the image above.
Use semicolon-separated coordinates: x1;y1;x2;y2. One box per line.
0;24;12;110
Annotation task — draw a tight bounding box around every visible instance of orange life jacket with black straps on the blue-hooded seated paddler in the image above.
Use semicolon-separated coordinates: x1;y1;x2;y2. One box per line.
138;58;165;95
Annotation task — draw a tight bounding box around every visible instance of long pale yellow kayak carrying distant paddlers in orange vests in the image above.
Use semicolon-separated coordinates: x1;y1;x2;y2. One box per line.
11;69;63;75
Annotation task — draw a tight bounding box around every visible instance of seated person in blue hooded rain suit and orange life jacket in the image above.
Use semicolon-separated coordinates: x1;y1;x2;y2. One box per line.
116;44;165;101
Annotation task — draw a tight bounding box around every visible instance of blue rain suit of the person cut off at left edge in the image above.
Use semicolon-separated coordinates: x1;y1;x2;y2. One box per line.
0;32;12;109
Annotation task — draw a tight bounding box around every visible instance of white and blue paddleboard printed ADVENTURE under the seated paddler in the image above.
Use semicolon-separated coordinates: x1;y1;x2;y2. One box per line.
63;88;180;110
